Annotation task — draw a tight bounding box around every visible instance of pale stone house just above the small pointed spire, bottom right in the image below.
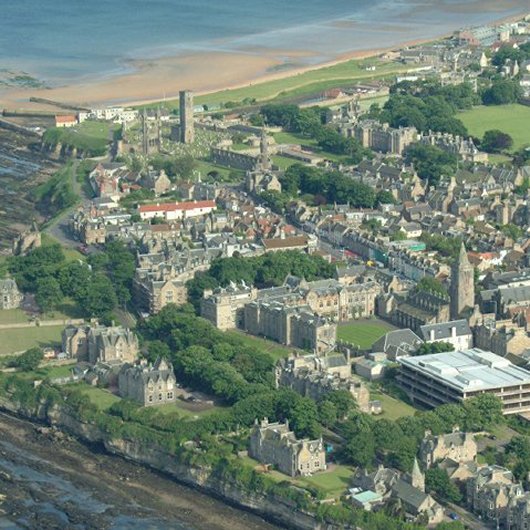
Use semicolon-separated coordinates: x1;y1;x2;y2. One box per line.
419;428;477;469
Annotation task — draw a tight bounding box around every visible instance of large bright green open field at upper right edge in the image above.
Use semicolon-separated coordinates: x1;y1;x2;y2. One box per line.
457;104;530;150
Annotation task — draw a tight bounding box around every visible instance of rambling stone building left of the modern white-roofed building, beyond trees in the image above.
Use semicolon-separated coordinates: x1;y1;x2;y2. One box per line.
276;353;370;412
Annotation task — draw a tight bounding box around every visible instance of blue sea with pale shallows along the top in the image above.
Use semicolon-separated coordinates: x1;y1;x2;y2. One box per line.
0;0;529;86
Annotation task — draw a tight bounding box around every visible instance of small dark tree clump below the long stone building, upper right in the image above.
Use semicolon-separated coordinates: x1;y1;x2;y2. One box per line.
403;143;458;186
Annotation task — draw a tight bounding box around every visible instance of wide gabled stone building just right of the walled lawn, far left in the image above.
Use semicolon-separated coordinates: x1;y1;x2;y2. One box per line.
62;322;139;364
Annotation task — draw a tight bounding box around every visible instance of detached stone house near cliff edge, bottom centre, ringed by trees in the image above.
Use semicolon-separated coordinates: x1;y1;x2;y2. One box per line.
249;419;326;477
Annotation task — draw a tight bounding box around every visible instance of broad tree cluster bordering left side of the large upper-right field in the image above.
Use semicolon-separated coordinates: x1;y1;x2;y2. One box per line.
369;81;474;136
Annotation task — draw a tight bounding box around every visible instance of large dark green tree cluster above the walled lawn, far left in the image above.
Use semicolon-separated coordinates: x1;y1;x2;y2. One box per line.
8;242;135;318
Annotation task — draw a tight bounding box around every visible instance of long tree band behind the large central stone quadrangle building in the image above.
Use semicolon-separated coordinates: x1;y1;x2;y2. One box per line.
187;251;334;308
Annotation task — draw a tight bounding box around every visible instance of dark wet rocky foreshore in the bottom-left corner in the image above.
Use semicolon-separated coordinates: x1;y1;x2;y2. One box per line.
0;414;278;530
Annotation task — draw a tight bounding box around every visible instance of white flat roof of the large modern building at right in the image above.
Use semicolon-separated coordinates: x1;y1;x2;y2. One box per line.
398;348;530;392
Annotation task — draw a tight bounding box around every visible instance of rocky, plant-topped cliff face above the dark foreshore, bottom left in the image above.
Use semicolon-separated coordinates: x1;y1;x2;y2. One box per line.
0;396;345;530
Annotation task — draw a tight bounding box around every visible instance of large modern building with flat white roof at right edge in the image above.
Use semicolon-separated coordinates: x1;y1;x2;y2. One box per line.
398;348;530;414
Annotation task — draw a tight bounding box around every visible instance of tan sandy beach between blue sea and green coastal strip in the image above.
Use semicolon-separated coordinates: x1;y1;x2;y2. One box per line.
0;13;526;110
